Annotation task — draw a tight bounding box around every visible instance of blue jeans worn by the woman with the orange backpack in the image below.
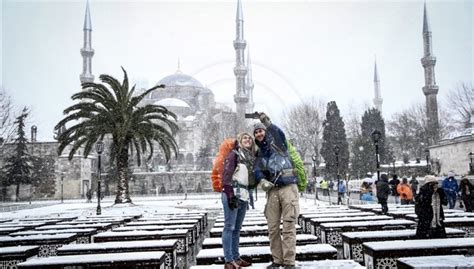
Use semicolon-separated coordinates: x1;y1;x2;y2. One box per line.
221;193;248;262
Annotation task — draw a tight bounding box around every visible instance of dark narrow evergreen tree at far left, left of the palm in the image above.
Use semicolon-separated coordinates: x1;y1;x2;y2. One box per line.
5;108;32;202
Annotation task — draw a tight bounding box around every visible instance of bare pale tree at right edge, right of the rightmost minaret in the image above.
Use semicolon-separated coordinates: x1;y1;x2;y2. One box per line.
445;83;474;130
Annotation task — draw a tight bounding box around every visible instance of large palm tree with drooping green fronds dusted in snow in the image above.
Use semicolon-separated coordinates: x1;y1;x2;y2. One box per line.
55;68;178;204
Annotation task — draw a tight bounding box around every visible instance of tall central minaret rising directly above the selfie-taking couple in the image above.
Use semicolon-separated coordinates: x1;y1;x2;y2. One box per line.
234;0;249;132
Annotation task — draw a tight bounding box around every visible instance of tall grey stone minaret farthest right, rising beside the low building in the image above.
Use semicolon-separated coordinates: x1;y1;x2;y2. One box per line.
421;2;439;145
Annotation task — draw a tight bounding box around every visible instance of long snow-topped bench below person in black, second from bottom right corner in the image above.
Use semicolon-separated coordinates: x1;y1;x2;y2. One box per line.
362;238;474;269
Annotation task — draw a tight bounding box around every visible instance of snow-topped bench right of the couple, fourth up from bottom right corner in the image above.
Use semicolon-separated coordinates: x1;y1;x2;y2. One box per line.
319;219;416;246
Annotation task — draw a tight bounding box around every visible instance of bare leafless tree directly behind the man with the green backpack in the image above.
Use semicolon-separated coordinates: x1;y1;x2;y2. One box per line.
283;98;326;160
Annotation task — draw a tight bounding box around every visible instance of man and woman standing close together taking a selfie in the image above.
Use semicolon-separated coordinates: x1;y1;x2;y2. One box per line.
222;113;299;269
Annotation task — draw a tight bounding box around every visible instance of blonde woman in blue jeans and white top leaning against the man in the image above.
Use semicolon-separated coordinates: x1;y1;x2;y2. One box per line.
222;133;255;269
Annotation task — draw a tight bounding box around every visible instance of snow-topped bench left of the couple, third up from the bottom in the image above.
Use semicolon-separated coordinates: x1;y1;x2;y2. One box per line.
94;230;189;254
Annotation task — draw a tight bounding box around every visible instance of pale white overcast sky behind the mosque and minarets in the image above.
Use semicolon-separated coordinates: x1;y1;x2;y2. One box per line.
0;0;474;141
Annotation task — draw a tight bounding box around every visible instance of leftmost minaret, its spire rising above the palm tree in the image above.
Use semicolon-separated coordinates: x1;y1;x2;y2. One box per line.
80;1;94;83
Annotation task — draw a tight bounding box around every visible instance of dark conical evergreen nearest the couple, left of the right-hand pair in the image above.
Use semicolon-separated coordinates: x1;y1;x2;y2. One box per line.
321;101;349;179
